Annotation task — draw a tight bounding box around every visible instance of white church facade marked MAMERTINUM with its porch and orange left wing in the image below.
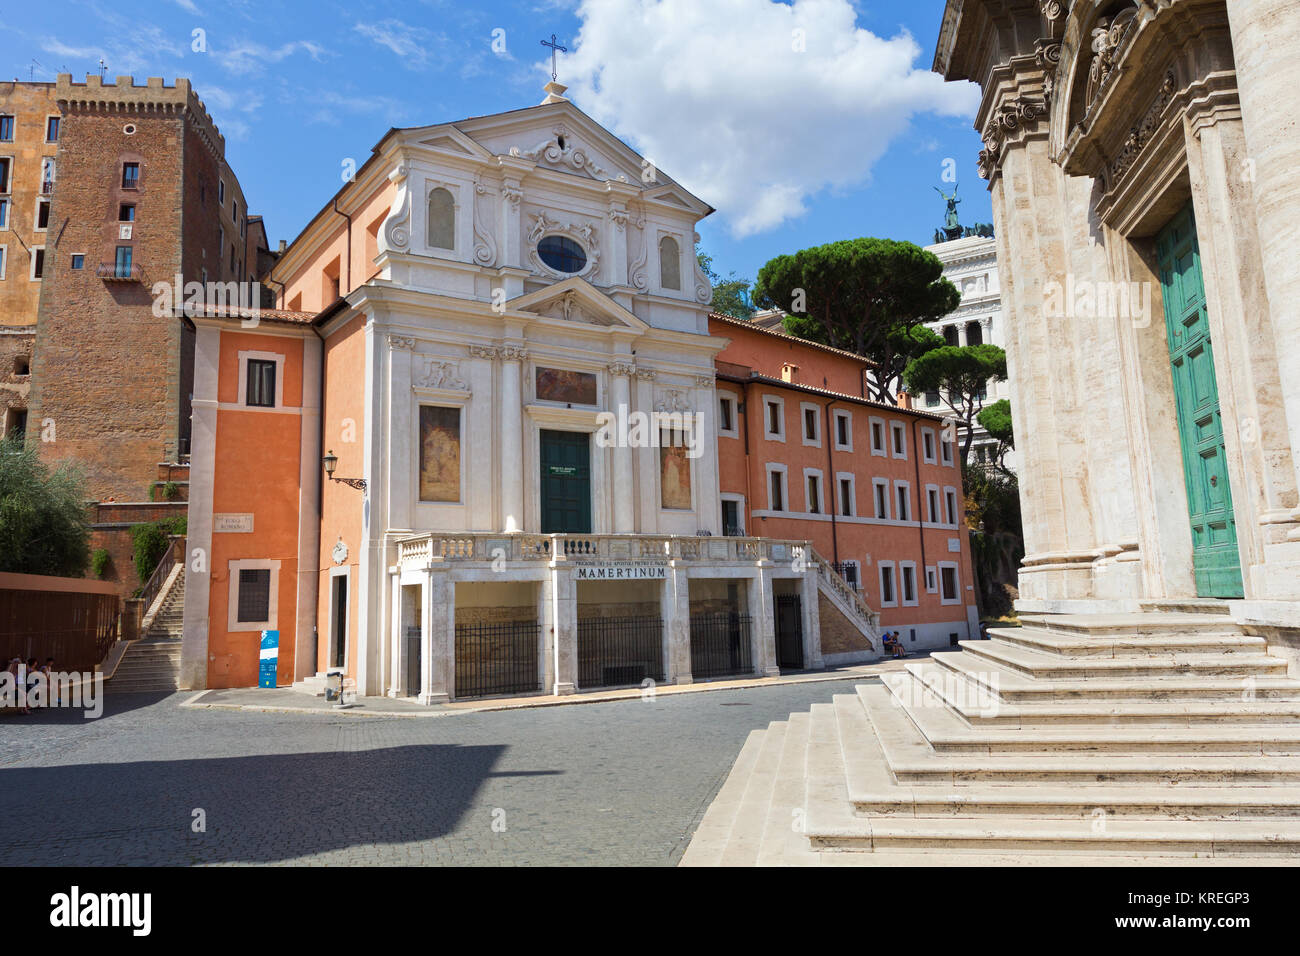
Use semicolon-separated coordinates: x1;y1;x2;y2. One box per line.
182;83;880;704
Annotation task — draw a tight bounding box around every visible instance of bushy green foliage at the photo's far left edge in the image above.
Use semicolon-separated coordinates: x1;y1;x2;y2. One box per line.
0;440;90;578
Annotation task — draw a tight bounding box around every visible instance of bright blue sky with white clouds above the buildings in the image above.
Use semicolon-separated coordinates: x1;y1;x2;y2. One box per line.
0;0;992;283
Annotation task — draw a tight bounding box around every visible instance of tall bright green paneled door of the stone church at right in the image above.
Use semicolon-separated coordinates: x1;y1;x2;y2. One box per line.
1156;203;1244;597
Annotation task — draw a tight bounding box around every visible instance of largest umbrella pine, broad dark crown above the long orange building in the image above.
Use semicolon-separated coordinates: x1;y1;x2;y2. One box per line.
754;237;961;405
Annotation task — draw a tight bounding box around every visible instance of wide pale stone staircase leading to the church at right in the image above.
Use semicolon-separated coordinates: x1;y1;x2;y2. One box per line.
681;613;1300;866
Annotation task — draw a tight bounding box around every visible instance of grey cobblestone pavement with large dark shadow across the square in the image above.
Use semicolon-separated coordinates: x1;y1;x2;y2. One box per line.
0;678;862;865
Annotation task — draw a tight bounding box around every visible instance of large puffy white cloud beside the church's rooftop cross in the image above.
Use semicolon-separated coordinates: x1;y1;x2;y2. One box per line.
559;0;978;237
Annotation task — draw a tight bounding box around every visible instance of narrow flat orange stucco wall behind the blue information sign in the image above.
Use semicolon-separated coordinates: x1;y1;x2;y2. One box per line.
208;330;311;687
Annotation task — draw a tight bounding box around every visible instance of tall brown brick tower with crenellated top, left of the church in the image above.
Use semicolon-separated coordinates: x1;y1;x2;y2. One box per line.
22;74;265;501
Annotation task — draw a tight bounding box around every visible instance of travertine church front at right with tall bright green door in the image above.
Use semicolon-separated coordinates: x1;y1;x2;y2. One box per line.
933;0;1300;653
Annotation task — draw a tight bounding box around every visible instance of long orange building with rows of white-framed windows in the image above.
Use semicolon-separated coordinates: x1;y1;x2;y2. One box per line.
710;313;979;663
